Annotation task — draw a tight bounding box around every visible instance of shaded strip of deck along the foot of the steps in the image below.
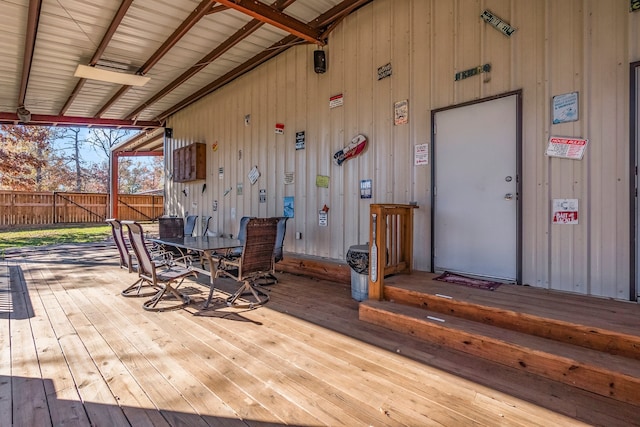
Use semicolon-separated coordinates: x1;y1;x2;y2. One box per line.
269;270;637;426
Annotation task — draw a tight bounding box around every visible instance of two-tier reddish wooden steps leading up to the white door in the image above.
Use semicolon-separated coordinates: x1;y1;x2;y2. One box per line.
359;273;640;406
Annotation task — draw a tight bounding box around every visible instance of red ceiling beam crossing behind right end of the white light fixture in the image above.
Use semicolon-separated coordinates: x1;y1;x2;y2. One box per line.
94;0;216;118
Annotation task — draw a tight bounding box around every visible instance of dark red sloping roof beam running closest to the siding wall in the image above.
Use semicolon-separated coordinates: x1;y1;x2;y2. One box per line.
156;35;299;121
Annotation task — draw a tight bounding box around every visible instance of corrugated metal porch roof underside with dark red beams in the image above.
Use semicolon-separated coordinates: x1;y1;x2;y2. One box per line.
0;0;371;139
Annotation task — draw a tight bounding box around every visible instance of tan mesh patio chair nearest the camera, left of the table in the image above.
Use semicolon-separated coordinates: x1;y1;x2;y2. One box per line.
122;221;198;311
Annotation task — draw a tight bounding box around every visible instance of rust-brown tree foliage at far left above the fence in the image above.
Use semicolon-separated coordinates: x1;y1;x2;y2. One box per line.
0;125;56;191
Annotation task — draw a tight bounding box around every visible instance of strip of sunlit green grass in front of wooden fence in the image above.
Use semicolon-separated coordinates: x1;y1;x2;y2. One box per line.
0;224;111;250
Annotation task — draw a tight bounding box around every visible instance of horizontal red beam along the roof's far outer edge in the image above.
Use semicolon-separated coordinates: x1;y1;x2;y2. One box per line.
0;112;162;129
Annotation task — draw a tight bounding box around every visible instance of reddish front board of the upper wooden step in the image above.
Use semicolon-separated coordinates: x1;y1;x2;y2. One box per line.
385;286;640;360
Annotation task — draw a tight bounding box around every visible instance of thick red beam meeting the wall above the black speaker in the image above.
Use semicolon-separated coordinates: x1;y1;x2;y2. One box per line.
218;0;326;46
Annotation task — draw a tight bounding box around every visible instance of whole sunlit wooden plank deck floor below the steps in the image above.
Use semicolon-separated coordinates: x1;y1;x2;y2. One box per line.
0;246;640;426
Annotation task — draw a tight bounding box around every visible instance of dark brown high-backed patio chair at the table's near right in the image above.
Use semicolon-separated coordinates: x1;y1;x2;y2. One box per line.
207;218;279;308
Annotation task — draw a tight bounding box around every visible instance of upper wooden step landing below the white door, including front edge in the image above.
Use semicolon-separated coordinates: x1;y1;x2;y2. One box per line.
385;282;640;360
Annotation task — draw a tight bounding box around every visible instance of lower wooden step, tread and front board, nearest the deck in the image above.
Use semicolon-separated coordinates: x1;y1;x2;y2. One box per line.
359;300;640;406
